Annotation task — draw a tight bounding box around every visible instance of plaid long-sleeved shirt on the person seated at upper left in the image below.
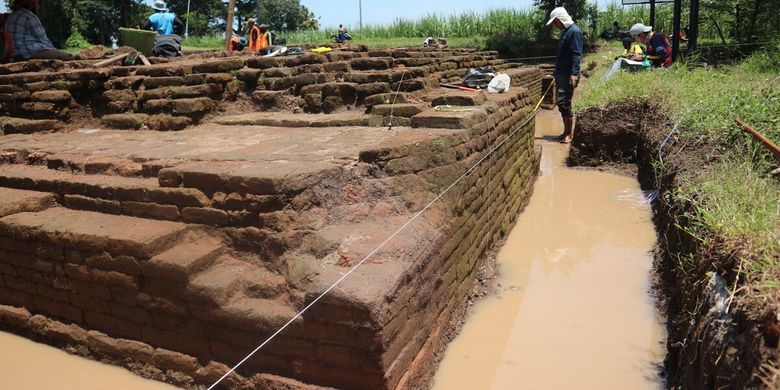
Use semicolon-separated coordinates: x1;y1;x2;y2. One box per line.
5;8;54;60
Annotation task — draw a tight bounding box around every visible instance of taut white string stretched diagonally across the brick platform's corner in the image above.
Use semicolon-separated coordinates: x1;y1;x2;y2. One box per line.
208;84;552;390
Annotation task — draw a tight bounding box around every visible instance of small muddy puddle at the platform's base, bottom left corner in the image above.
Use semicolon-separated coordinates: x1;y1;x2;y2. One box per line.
0;332;175;390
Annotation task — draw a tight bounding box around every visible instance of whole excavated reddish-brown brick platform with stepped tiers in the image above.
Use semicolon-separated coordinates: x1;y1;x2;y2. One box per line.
0;49;543;389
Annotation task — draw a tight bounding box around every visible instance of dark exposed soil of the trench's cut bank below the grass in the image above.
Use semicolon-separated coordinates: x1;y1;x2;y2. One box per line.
568;101;778;388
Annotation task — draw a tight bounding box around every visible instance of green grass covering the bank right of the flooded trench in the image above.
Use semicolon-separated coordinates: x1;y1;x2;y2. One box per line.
575;45;780;294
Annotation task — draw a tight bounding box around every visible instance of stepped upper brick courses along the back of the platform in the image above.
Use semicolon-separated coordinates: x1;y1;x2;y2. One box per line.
0;47;536;134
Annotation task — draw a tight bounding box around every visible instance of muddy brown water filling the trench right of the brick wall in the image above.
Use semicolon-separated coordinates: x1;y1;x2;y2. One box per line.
434;111;666;390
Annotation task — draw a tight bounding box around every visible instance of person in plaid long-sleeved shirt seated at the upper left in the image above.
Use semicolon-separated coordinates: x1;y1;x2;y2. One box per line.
5;0;73;61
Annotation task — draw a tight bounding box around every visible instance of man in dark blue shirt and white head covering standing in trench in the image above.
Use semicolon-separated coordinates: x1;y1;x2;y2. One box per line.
547;7;583;144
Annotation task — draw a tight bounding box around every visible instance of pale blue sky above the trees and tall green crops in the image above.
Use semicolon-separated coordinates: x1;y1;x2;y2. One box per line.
0;0;610;29
